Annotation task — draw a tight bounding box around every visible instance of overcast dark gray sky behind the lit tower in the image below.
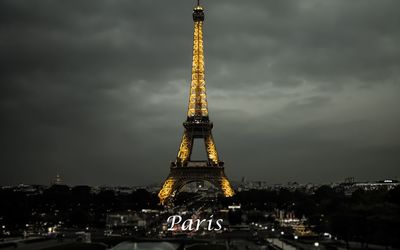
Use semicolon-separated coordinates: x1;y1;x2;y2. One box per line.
0;0;400;185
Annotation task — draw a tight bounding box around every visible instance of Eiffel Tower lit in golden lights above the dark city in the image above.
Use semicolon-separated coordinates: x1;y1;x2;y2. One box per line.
158;1;234;204
